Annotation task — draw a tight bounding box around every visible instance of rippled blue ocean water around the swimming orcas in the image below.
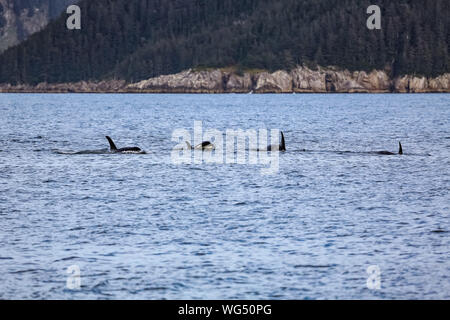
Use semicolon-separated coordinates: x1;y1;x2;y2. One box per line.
0;94;450;299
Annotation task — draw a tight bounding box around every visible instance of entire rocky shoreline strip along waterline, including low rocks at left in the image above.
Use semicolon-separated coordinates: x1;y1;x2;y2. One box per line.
0;66;450;93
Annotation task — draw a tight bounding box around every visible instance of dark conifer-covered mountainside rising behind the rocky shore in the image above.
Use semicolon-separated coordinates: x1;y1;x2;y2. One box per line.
0;0;450;84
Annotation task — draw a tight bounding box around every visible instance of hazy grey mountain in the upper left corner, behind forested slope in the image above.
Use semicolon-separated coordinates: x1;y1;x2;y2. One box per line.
0;0;77;52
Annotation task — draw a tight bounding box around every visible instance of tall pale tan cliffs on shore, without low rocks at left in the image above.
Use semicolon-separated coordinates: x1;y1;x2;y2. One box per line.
126;67;450;93
